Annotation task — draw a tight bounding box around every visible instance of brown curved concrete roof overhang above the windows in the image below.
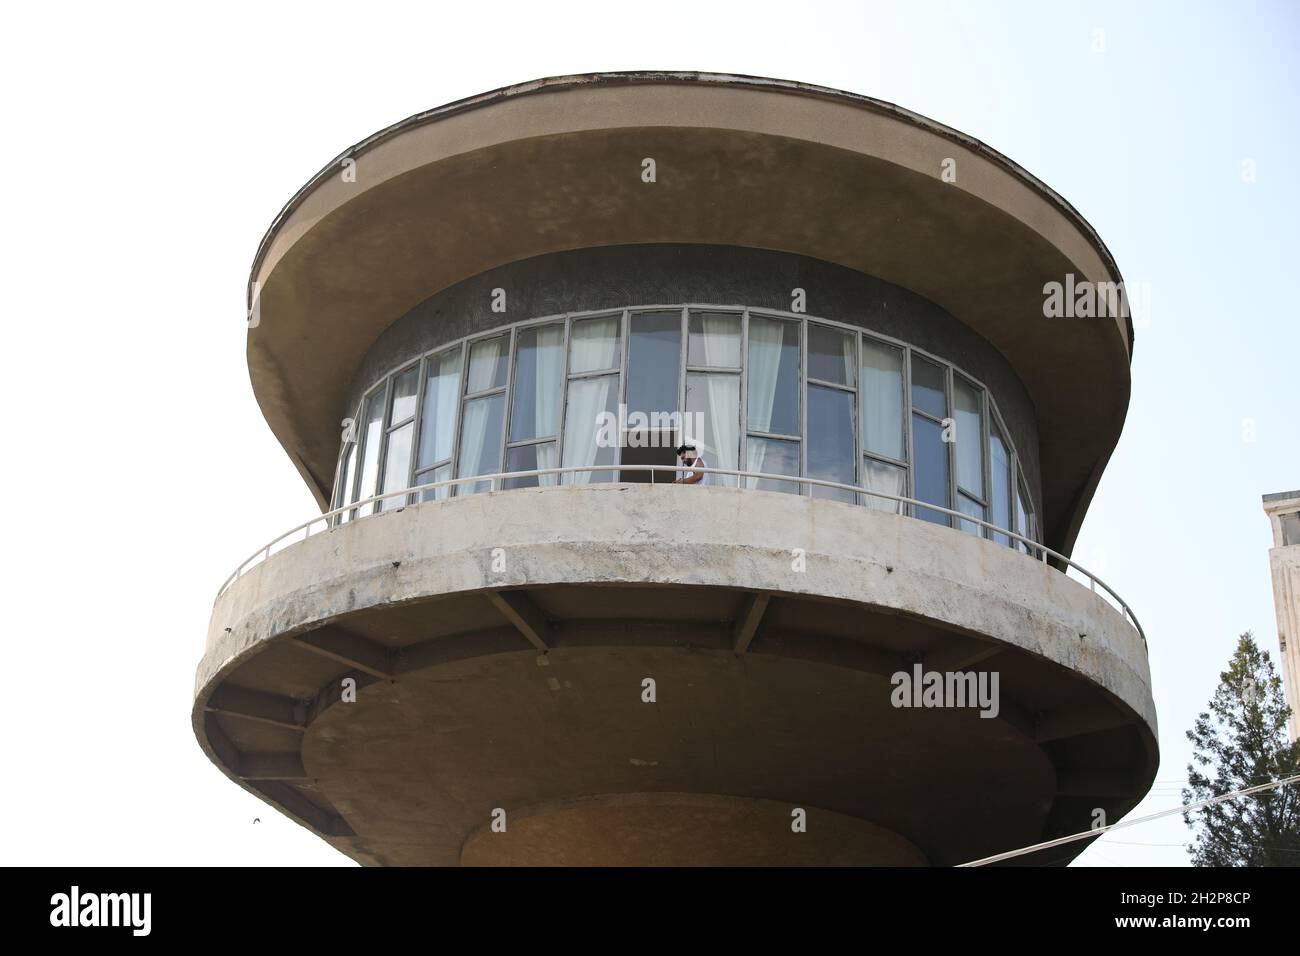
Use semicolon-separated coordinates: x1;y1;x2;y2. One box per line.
247;73;1132;553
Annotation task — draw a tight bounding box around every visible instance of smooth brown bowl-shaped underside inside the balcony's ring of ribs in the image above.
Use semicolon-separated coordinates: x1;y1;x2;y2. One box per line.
303;642;1055;865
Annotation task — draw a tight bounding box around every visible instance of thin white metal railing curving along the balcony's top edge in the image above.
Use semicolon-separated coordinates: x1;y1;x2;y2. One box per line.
217;464;1147;645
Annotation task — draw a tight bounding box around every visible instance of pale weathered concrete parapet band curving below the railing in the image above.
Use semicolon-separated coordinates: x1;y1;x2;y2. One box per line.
195;484;1156;731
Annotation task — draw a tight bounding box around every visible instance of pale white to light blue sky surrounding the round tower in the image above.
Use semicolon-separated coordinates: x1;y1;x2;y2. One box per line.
0;0;1300;865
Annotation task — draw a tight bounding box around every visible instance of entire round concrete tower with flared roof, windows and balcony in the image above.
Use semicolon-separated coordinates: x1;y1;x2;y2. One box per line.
194;73;1157;865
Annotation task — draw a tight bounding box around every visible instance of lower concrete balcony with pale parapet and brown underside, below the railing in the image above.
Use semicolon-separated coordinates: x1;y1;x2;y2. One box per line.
194;484;1157;864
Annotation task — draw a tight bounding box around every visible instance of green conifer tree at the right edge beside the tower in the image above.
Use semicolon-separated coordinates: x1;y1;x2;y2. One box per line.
1183;631;1300;866
